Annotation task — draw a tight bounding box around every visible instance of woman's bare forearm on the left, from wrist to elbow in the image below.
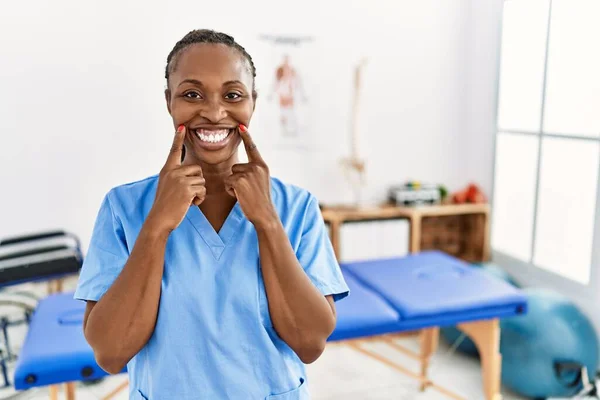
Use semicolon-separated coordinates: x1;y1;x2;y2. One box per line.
84;220;169;373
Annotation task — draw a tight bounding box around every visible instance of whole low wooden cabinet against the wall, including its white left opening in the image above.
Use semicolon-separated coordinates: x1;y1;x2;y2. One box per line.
321;204;490;262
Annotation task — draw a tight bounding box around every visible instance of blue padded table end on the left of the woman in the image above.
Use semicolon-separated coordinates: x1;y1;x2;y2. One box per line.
15;293;106;390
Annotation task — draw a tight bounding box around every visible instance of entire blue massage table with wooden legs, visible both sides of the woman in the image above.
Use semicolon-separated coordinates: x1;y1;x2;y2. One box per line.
14;251;526;400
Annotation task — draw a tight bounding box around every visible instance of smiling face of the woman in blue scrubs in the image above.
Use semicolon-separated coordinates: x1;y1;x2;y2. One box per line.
165;44;254;164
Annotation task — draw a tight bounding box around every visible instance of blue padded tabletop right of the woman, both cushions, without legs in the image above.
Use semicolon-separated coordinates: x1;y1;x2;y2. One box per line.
330;251;527;340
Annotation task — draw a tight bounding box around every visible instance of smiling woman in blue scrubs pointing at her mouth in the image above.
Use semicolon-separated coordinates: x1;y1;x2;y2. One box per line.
75;30;348;400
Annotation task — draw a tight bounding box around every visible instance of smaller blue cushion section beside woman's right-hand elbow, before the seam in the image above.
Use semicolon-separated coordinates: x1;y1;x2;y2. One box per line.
329;270;400;341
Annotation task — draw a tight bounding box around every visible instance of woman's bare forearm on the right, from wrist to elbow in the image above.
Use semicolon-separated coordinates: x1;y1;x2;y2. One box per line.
256;218;335;364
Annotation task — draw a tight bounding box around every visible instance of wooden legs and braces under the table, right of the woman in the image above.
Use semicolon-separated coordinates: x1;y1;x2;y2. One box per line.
334;319;502;400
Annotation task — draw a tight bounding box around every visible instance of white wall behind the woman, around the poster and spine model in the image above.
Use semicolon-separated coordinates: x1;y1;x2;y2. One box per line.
0;0;474;250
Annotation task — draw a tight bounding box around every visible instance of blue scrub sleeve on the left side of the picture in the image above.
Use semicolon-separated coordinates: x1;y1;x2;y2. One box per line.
74;192;129;301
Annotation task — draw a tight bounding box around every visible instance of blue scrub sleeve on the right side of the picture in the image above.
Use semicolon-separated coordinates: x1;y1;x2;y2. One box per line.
296;195;350;301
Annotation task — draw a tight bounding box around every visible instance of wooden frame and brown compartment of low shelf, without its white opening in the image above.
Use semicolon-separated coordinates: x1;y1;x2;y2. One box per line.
321;204;490;262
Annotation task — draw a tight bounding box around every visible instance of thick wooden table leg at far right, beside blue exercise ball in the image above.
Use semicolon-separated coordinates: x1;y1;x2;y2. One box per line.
458;319;502;400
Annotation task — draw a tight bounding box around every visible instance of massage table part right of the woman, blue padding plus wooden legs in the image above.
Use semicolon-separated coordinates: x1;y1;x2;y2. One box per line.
329;251;527;400
